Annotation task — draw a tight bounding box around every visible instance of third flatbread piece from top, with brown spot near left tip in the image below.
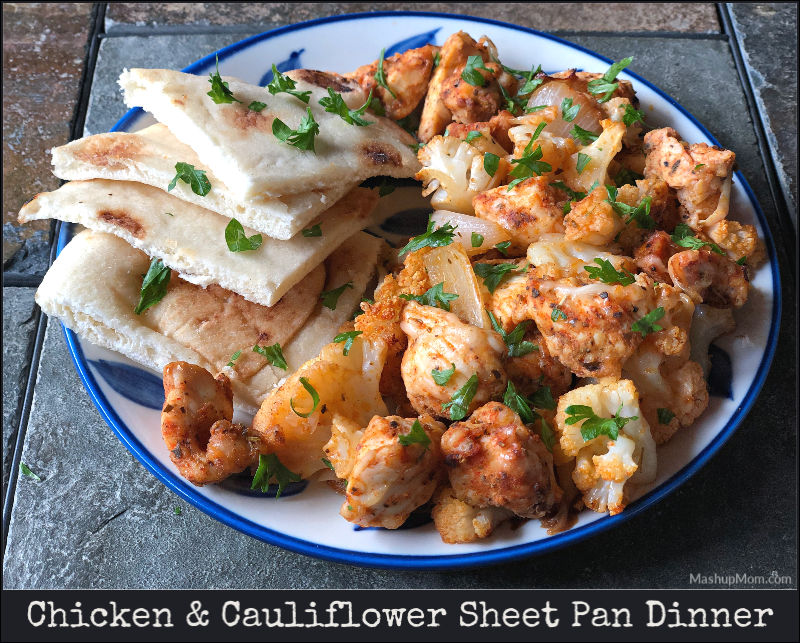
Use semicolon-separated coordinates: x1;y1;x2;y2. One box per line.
19;179;378;306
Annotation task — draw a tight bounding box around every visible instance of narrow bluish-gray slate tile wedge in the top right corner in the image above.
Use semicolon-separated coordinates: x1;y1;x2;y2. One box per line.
728;2;797;221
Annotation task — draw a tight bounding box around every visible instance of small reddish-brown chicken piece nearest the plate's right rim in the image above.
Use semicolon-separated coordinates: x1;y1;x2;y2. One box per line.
668;248;750;308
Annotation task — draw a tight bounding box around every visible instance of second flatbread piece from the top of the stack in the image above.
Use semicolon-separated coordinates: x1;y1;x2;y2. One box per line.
52;123;358;240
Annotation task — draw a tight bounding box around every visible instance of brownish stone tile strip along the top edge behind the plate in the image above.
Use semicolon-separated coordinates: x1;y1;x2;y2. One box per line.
106;2;719;33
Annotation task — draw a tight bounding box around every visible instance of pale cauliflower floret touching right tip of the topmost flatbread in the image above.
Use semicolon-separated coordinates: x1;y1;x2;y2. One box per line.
416;136;505;214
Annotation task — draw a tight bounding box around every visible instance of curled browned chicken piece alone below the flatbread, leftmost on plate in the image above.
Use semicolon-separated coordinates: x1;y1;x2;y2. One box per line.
161;362;260;487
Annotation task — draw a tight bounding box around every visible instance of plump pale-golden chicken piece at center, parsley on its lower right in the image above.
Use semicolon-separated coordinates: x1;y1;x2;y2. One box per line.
400;301;507;419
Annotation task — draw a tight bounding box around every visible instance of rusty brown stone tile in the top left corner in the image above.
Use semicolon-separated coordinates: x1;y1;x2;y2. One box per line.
3;2;92;275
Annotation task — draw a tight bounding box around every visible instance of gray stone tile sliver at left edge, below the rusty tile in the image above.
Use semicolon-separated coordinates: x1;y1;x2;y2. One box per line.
3;287;36;497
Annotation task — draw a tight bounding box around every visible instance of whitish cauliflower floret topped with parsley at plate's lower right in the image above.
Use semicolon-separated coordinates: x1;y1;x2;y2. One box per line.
556;380;656;516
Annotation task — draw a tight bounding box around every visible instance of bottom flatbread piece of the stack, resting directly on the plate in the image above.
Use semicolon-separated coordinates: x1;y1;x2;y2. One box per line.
36;230;381;413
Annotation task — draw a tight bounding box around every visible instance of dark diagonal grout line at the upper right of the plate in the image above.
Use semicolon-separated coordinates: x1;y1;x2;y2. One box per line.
717;2;797;278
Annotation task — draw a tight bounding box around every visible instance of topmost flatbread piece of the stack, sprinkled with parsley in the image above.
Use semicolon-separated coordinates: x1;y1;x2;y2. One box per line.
119;69;419;199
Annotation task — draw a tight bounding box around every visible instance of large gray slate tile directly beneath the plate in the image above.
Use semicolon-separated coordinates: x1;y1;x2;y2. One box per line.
3;35;797;588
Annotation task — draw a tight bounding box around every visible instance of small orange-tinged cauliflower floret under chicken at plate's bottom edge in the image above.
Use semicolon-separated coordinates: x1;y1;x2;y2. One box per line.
431;485;514;544
